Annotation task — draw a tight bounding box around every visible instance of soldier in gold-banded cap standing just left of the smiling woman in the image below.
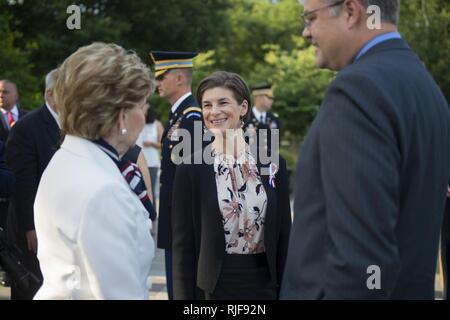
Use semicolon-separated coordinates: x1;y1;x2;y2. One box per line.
150;51;202;300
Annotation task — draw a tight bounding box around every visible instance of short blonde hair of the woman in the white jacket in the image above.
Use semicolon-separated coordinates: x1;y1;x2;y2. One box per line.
54;42;154;139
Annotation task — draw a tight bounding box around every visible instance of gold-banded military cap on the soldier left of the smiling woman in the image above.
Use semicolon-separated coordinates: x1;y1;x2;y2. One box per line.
150;51;198;78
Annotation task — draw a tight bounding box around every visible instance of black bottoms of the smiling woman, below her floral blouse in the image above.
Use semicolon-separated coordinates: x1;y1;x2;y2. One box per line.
205;253;277;300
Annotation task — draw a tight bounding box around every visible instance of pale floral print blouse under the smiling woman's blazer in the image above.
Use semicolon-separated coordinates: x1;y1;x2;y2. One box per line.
213;145;267;254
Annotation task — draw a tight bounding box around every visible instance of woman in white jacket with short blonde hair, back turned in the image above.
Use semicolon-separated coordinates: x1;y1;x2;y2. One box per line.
34;43;154;299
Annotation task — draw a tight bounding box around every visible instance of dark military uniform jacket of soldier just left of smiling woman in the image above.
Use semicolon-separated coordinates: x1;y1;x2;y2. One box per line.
157;95;202;250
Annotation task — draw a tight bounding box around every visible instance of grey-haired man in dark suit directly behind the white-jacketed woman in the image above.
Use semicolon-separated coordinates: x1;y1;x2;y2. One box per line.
6;70;60;299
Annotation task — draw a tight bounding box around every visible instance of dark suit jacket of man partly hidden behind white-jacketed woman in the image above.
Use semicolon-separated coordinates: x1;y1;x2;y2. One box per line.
6;105;60;233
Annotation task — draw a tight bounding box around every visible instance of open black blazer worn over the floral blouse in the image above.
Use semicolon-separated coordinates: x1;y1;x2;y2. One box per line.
172;154;291;300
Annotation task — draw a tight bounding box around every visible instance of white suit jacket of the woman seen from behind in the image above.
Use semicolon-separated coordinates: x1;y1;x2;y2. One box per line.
34;135;155;299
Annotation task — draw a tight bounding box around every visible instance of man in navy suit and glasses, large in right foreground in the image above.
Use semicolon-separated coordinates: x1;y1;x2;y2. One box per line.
281;0;450;299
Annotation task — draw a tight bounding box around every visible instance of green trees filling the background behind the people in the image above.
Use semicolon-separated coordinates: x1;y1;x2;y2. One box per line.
0;0;450;159
